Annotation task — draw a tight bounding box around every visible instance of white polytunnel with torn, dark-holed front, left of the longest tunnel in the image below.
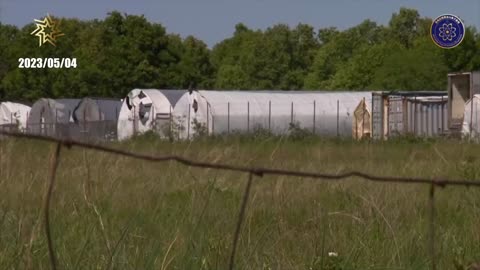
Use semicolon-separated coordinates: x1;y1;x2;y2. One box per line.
117;89;186;140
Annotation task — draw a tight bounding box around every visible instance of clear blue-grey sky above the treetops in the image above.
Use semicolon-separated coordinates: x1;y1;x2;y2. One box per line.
0;0;480;47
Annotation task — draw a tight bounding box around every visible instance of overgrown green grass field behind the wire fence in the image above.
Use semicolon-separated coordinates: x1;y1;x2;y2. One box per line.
0;134;480;270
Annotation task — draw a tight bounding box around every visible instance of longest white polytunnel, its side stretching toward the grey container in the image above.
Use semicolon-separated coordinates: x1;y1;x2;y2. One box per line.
173;90;372;139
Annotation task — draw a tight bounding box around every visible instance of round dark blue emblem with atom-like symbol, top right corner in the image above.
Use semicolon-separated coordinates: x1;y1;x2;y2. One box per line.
430;14;465;49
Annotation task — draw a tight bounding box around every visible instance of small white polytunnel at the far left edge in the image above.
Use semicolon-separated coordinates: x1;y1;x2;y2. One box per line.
0;101;31;131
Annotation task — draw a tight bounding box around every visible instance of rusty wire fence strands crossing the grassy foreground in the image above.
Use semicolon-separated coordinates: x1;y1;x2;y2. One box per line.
0;130;480;270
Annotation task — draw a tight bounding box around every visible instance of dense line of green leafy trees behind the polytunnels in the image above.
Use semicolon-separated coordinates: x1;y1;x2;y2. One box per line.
0;8;480;100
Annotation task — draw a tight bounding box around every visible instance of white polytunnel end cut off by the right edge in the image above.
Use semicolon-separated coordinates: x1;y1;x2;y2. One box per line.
462;94;480;138
